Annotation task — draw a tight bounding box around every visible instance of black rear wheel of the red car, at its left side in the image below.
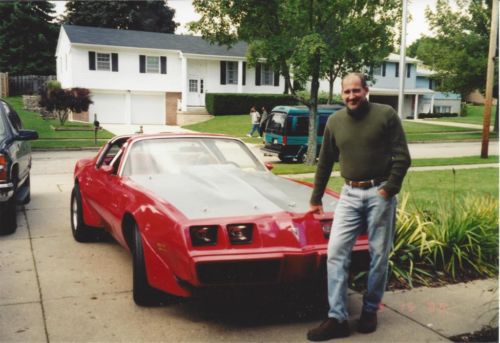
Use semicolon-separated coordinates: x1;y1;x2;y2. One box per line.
70;185;103;243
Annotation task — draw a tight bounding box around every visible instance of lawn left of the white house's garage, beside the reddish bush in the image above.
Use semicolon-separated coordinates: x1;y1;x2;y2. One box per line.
5;96;114;149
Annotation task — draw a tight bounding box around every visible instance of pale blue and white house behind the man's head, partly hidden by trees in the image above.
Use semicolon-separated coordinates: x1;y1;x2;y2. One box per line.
320;54;461;118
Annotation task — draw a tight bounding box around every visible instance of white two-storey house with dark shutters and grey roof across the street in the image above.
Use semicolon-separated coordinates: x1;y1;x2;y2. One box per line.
56;25;284;125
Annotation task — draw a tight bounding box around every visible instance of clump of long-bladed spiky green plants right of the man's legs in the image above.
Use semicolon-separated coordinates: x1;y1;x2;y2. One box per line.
382;195;498;287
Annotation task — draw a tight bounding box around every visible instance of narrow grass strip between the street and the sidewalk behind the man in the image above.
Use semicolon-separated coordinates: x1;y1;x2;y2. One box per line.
273;155;499;175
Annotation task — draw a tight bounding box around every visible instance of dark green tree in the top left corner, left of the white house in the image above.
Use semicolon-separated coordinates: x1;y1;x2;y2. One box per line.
0;1;58;75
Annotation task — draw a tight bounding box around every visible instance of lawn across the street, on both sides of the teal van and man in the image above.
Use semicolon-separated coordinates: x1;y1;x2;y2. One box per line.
183;115;498;143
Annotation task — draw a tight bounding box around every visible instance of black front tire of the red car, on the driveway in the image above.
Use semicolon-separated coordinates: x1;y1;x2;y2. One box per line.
132;223;166;306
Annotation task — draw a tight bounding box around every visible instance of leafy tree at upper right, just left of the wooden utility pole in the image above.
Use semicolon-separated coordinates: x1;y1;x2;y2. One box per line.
409;0;491;99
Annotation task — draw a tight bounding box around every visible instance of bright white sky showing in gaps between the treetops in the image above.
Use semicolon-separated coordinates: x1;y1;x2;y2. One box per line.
52;0;437;46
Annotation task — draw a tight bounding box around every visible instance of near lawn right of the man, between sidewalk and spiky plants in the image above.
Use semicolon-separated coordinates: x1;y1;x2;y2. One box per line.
298;168;498;207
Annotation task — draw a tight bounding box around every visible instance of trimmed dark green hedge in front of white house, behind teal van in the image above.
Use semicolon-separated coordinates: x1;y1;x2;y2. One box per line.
205;93;299;115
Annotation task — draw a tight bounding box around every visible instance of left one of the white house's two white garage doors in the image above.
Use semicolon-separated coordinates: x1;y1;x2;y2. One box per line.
89;93;126;124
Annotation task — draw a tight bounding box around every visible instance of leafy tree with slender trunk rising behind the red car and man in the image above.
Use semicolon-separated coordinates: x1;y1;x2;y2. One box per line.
190;0;400;164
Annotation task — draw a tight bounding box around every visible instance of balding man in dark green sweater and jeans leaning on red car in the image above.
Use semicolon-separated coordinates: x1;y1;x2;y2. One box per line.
307;73;411;341
